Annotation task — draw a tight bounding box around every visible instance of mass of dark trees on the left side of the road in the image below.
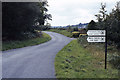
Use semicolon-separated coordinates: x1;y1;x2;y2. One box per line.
2;1;52;41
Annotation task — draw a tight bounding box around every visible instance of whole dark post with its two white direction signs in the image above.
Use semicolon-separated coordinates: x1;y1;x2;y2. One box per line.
87;30;107;69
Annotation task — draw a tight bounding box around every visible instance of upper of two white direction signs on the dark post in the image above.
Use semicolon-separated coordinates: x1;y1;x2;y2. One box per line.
87;30;106;36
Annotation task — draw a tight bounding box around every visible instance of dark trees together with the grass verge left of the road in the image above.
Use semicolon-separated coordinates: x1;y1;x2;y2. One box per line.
2;0;52;50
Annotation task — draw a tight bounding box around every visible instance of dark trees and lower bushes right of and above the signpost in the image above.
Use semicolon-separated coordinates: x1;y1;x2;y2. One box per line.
87;1;120;70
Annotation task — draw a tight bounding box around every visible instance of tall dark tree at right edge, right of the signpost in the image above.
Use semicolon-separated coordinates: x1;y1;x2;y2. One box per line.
107;2;120;47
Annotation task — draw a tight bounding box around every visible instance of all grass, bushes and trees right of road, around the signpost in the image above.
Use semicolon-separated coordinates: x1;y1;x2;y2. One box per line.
55;2;120;78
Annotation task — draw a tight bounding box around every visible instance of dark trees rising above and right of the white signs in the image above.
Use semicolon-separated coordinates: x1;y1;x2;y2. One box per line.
88;2;120;48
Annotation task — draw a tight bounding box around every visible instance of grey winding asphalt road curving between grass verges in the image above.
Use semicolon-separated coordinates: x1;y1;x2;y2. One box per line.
2;31;73;78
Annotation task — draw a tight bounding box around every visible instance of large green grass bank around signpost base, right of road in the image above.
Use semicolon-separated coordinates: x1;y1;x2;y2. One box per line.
55;40;118;78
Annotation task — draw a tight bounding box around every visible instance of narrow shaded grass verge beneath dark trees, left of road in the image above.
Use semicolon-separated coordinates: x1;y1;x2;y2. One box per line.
2;33;51;51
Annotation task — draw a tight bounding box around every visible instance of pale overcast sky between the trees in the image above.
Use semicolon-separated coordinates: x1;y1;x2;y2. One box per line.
48;0;120;26
